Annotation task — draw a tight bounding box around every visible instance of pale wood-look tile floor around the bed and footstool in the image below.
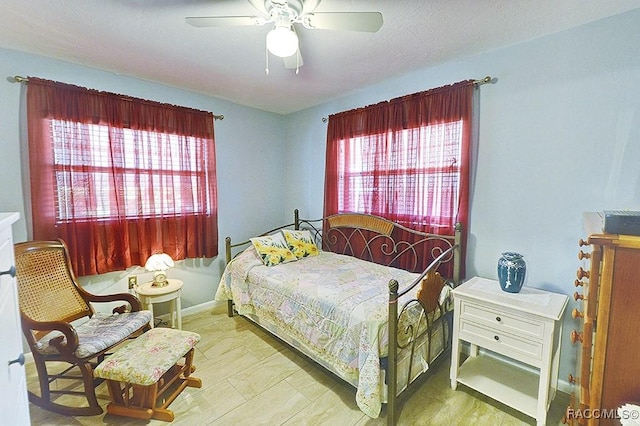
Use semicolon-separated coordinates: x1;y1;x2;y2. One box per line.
25;305;568;426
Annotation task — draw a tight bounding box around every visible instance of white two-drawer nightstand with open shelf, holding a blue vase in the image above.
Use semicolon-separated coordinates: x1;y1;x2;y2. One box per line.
450;277;568;426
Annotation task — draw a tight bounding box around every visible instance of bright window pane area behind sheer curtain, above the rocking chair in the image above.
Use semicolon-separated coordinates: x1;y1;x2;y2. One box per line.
50;120;212;223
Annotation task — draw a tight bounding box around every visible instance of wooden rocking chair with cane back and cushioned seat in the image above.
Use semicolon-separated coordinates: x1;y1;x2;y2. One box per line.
15;240;152;416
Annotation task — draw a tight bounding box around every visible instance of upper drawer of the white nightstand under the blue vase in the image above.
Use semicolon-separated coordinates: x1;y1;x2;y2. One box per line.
460;301;544;339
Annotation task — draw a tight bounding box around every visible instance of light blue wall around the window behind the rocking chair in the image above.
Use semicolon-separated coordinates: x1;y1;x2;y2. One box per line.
0;49;285;314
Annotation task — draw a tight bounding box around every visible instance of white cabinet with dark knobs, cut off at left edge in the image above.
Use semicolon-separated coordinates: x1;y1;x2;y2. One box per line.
0;213;30;425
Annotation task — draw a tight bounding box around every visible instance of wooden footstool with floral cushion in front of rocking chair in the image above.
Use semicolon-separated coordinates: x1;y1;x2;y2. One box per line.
94;328;202;422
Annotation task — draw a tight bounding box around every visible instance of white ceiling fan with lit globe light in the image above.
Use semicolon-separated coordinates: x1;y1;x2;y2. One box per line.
185;0;382;74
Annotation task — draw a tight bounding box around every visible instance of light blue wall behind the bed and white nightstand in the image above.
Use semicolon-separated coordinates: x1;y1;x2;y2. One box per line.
283;10;640;390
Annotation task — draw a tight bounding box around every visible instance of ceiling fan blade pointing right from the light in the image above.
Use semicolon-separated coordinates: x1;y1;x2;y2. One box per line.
304;12;382;33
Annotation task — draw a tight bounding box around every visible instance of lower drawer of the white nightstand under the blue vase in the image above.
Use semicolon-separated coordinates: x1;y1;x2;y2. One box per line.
459;318;542;366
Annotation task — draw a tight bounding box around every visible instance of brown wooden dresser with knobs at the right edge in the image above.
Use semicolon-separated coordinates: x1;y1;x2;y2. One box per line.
565;213;640;425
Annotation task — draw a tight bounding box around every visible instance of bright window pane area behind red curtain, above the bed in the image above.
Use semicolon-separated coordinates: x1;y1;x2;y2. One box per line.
338;120;463;227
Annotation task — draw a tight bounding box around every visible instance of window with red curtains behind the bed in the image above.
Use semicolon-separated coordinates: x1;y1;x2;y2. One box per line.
324;80;474;274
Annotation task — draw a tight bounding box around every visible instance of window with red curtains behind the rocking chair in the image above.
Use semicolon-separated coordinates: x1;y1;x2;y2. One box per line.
27;77;218;276
